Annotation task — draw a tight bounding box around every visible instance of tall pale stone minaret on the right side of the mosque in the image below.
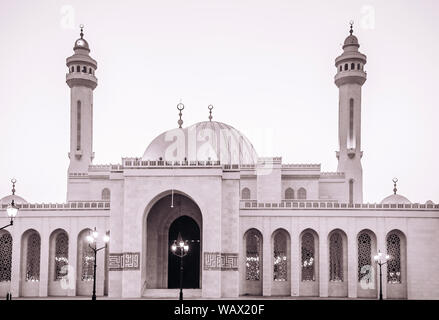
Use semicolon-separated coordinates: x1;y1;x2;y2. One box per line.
334;22;366;203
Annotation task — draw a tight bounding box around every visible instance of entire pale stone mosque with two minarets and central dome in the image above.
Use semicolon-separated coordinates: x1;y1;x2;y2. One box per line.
0;25;439;299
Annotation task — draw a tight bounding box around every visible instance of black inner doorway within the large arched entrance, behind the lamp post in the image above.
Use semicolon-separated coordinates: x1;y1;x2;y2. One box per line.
168;216;200;289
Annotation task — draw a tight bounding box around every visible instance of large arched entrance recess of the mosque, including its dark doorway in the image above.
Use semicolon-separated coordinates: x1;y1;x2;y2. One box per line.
146;193;203;290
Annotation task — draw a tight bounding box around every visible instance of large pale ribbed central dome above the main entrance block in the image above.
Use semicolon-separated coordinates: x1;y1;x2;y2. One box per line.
143;121;258;164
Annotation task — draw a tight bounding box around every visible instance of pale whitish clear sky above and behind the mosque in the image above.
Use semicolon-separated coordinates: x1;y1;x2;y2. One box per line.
0;0;439;203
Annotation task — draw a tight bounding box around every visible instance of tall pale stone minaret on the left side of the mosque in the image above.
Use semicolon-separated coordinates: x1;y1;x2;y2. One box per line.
66;25;98;173
